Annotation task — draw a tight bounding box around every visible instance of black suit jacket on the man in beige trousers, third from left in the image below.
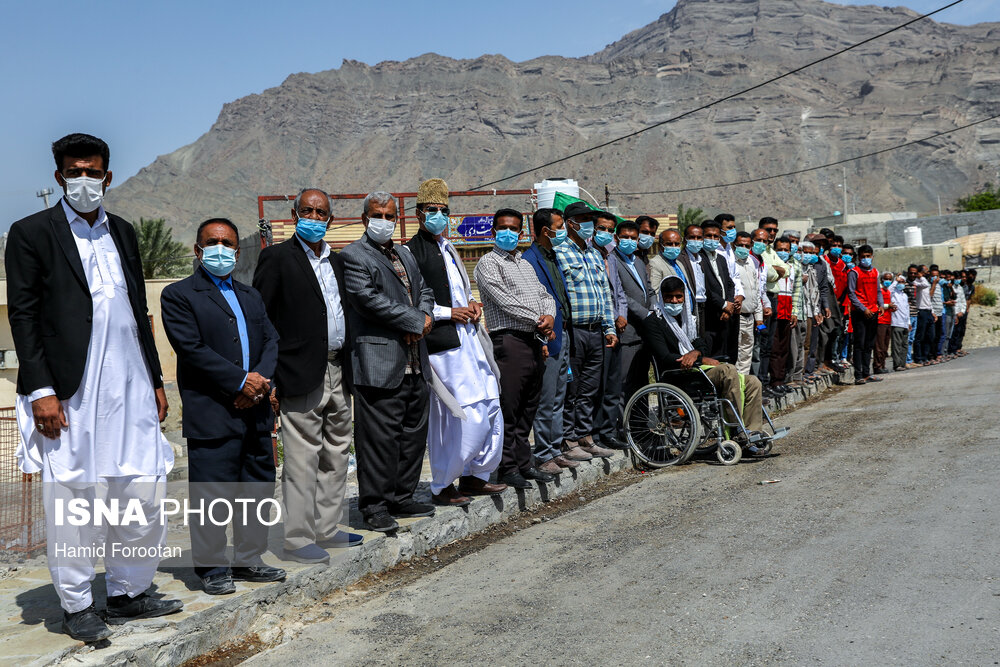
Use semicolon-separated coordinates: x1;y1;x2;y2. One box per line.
253;236;351;396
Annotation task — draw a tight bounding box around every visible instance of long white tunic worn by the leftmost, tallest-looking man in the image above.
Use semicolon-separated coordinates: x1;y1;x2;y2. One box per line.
17;201;174;482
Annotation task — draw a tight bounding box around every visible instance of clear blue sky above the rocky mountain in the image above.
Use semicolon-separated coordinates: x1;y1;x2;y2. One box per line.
0;0;988;231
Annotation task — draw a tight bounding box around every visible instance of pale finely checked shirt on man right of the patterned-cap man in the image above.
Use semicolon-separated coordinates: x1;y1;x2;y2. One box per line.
474;248;556;333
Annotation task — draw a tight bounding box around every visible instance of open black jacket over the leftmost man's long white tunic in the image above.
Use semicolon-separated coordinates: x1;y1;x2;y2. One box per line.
4;200;163;400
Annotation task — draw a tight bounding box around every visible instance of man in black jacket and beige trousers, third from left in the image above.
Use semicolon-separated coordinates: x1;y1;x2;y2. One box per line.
253;188;362;563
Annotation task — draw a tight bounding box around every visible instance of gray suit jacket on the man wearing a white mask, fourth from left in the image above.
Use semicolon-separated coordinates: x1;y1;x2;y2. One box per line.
340;234;434;389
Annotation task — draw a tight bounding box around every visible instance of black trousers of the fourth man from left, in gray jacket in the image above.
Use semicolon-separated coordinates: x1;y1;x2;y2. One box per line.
354;375;430;517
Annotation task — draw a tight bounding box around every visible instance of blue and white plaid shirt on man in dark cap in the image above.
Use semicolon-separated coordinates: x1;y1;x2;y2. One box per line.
556;239;615;335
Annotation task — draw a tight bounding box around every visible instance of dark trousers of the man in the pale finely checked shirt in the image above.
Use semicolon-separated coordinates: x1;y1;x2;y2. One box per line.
490;332;540;477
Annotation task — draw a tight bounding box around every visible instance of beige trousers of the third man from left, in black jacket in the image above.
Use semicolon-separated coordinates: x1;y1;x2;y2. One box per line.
280;361;352;551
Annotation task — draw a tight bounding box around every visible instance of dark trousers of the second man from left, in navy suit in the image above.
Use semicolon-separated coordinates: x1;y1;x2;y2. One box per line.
188;434;275;577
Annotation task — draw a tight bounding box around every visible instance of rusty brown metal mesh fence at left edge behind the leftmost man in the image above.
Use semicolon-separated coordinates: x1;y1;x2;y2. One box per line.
0;408;45;554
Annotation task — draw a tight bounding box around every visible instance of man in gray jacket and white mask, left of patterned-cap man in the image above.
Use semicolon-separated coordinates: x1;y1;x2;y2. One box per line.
341;192;434;532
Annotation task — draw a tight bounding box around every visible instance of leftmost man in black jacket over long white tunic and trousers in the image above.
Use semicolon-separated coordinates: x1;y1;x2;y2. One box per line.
5;134;182;641
